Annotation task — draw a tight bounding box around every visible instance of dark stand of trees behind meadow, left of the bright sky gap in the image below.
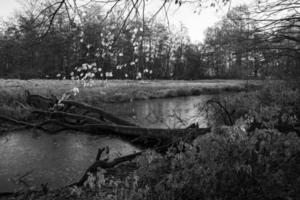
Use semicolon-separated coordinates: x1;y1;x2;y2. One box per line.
0;3;206;80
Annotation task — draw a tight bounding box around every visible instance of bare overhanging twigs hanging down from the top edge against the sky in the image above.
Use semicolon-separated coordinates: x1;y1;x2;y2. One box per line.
29;0;230;36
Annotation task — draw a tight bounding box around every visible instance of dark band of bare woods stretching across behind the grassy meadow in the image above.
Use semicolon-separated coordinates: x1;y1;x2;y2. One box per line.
0;0;300;79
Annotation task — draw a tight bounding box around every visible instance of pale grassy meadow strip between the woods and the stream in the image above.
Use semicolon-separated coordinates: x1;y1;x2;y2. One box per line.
0;79;262;105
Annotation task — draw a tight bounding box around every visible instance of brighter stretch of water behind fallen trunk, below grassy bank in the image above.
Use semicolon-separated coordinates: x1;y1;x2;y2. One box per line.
104;95;212;128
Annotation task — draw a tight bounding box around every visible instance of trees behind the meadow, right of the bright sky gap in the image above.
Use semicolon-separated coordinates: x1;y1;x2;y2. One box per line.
202;3;299;79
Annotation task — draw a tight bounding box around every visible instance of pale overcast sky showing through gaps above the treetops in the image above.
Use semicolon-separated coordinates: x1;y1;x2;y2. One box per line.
0;0;249;42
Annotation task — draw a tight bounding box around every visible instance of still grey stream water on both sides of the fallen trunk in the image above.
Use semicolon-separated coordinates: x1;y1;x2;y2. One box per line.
0;96;211;192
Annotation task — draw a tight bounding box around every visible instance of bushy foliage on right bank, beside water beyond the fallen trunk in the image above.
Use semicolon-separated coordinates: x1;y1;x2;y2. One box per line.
206;82;300;132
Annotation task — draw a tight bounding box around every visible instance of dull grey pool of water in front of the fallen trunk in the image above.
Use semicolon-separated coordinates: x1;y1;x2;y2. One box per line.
0;132;138;192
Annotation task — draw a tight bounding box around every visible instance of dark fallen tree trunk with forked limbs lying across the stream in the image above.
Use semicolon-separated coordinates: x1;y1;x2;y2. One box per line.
0;94;210;148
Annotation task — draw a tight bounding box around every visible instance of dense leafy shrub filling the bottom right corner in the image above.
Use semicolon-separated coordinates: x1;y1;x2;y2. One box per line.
132;127;300;199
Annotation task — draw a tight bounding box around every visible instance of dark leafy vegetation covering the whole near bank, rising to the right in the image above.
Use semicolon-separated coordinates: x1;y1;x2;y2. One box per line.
0;83;300;199
